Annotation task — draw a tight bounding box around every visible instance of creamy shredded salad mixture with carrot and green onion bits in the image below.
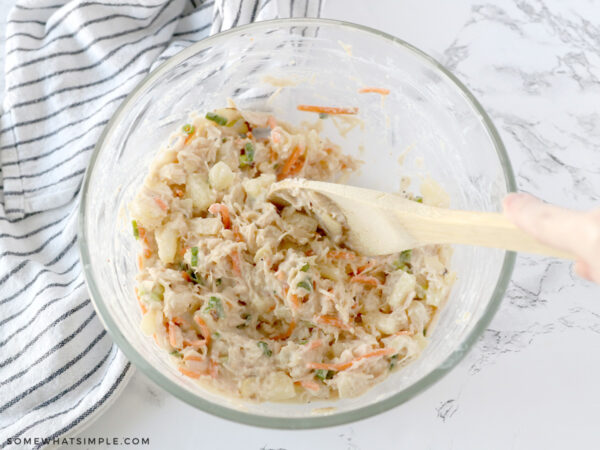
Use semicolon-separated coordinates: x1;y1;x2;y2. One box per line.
130;105;454;402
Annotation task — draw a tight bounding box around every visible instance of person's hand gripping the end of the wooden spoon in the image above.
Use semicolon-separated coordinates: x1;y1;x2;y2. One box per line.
503;193;600;283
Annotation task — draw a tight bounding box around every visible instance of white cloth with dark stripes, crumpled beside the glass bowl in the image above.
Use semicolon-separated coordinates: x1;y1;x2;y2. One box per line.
0;0;322;448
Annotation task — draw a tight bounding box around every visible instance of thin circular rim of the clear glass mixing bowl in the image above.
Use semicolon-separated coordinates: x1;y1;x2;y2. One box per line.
78;18;516;429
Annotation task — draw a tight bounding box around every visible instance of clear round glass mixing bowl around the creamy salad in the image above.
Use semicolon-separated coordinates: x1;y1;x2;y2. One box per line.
79;19;515;428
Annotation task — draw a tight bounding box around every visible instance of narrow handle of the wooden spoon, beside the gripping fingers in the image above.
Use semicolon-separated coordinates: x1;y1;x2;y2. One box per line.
417;210;577;260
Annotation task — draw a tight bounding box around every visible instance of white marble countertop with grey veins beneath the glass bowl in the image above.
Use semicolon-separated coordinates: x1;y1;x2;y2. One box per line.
4;0;600;450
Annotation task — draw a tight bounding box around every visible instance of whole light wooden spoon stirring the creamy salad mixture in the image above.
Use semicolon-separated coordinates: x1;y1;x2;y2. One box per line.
269;178;576;259
